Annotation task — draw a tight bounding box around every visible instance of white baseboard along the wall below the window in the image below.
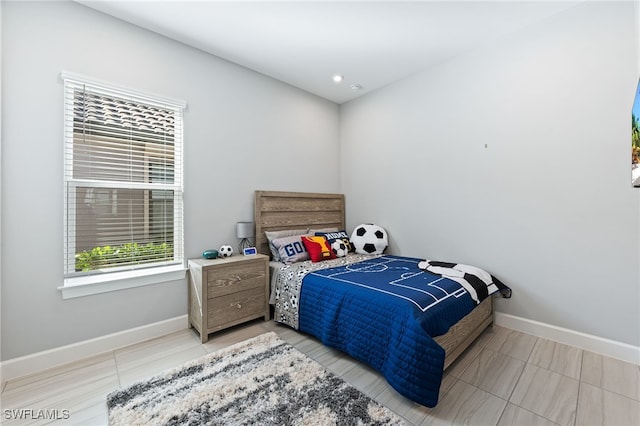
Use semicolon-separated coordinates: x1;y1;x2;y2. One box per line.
0;315;188;381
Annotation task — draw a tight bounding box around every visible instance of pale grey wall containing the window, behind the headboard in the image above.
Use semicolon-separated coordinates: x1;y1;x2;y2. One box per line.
1;2;339;360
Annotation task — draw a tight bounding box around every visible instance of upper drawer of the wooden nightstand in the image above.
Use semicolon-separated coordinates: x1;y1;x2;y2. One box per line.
207;262;266;299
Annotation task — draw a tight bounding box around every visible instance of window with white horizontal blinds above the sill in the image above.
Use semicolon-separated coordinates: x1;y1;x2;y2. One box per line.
63;74;186;297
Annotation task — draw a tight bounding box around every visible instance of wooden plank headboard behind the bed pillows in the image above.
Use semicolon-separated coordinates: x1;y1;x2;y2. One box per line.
254;191;346;255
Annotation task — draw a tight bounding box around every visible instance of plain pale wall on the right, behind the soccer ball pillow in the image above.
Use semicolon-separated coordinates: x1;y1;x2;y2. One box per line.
341;2;640;346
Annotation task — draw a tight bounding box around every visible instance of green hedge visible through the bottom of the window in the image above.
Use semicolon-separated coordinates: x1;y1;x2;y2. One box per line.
76;243;173;272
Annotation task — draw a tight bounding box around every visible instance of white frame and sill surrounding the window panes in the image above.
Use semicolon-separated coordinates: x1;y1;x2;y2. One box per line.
58;71;187;299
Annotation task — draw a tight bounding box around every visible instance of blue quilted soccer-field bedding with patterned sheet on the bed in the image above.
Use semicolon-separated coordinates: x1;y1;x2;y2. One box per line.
271;255;506;407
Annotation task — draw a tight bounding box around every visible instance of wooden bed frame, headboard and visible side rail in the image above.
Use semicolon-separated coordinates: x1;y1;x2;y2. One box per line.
254;191;494;369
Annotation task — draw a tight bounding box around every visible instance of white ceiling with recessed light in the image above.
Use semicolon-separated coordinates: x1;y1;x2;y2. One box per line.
76;0;577;104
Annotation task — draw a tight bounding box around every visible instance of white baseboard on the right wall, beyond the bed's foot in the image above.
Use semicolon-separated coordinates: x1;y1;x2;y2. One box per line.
495;312;640;365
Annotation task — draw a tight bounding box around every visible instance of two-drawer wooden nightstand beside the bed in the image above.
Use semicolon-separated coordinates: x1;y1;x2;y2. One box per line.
189;254;270;343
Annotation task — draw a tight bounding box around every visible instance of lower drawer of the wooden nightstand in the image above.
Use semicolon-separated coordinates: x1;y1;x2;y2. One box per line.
207;287;266;329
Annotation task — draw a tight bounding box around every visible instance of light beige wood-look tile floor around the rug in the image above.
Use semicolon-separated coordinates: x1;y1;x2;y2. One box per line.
0;320;640;426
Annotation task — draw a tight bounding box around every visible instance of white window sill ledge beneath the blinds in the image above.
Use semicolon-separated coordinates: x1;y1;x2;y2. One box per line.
58;265;186;299
